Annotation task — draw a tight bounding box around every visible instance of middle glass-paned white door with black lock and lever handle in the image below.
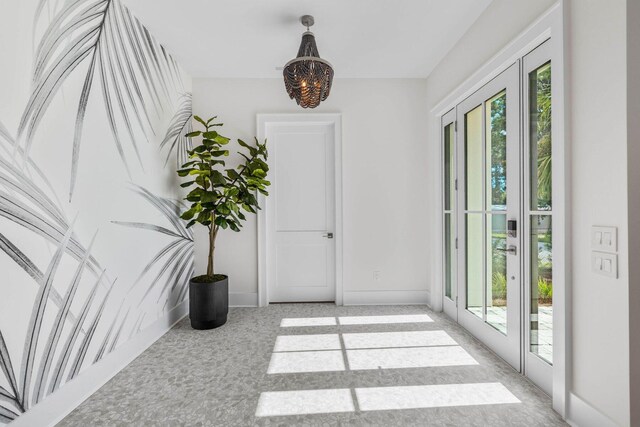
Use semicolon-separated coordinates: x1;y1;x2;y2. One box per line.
457;63;521;370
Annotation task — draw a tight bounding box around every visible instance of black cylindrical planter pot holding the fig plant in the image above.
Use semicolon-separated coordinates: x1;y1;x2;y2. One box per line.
189;276;229;329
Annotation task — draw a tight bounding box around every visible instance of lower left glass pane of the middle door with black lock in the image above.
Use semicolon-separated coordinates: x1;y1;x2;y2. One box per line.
466;214;484;318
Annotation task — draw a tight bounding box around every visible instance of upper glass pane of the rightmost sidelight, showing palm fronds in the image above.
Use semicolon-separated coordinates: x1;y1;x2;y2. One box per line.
529;63;552;211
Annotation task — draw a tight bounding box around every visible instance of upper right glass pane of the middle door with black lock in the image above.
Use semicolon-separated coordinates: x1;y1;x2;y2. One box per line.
485;91;507;211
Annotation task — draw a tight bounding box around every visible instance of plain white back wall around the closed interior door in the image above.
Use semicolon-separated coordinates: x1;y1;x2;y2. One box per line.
193;79;428;302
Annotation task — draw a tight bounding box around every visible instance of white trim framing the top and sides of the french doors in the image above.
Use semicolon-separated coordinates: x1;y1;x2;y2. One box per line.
430;0;572;416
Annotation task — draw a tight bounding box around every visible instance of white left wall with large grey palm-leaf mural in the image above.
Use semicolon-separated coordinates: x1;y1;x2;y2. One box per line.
0;0;193;425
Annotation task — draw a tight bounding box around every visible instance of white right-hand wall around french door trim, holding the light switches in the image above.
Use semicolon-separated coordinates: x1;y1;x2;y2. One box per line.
427;0;630;425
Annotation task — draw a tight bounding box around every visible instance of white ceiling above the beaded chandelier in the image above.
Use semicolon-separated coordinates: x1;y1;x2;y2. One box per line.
125;0;491;78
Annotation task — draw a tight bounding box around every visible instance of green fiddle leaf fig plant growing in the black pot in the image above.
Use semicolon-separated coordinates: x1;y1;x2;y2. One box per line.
178;116;271;282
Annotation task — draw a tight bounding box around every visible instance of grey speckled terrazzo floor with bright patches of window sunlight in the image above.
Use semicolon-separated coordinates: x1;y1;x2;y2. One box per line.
58;304;566;427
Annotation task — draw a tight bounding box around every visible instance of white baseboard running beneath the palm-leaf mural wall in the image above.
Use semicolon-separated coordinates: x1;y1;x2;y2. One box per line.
11;300;189;427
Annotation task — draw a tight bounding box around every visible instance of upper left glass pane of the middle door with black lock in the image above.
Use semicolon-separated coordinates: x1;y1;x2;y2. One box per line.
464;105;484;211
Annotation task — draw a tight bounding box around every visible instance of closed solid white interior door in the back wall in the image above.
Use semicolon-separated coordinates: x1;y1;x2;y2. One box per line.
264;121;336;302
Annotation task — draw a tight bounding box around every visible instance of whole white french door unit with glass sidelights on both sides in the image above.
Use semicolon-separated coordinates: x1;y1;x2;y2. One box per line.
442;43;553;393
